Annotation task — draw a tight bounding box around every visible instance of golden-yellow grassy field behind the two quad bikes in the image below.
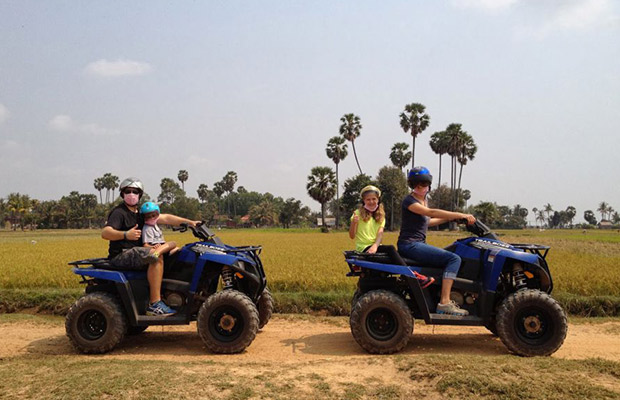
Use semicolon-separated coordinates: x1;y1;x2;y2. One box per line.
0;230;620;296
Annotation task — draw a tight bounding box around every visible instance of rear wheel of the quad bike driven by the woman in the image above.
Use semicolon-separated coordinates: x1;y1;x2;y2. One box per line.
349;290;413;354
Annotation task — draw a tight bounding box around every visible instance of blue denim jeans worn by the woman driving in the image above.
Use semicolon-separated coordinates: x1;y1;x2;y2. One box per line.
398;242;461;279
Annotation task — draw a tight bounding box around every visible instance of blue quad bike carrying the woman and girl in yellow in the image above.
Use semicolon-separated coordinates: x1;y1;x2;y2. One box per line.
345;221;567;356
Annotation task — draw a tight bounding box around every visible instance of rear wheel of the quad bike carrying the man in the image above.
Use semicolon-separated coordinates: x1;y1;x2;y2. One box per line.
65;293;127;354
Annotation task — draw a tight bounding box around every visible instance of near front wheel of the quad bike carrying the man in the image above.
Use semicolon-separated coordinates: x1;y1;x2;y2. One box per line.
197;290;258;354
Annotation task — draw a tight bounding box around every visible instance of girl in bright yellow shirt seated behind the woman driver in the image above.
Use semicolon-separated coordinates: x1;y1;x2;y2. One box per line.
349;185;435;289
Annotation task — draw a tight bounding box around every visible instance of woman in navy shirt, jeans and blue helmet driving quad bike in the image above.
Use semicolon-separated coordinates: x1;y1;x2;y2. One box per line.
398;167;476;316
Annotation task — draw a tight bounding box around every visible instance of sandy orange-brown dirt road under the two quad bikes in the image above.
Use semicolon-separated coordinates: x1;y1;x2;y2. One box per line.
0;315;620;363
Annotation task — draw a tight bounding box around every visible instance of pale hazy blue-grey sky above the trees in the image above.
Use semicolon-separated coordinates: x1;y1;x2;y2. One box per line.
0;0;620;220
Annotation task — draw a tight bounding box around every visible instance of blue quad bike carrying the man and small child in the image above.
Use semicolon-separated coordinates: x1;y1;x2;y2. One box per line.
65;223;273;353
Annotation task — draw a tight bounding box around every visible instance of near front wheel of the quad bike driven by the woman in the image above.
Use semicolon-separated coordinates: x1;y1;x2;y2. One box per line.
496;289;568;357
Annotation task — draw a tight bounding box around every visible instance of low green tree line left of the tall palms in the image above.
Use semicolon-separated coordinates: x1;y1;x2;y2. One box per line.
0;170;316;230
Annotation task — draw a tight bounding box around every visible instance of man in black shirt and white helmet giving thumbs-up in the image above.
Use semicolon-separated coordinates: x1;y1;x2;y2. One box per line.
101;177;198;315
